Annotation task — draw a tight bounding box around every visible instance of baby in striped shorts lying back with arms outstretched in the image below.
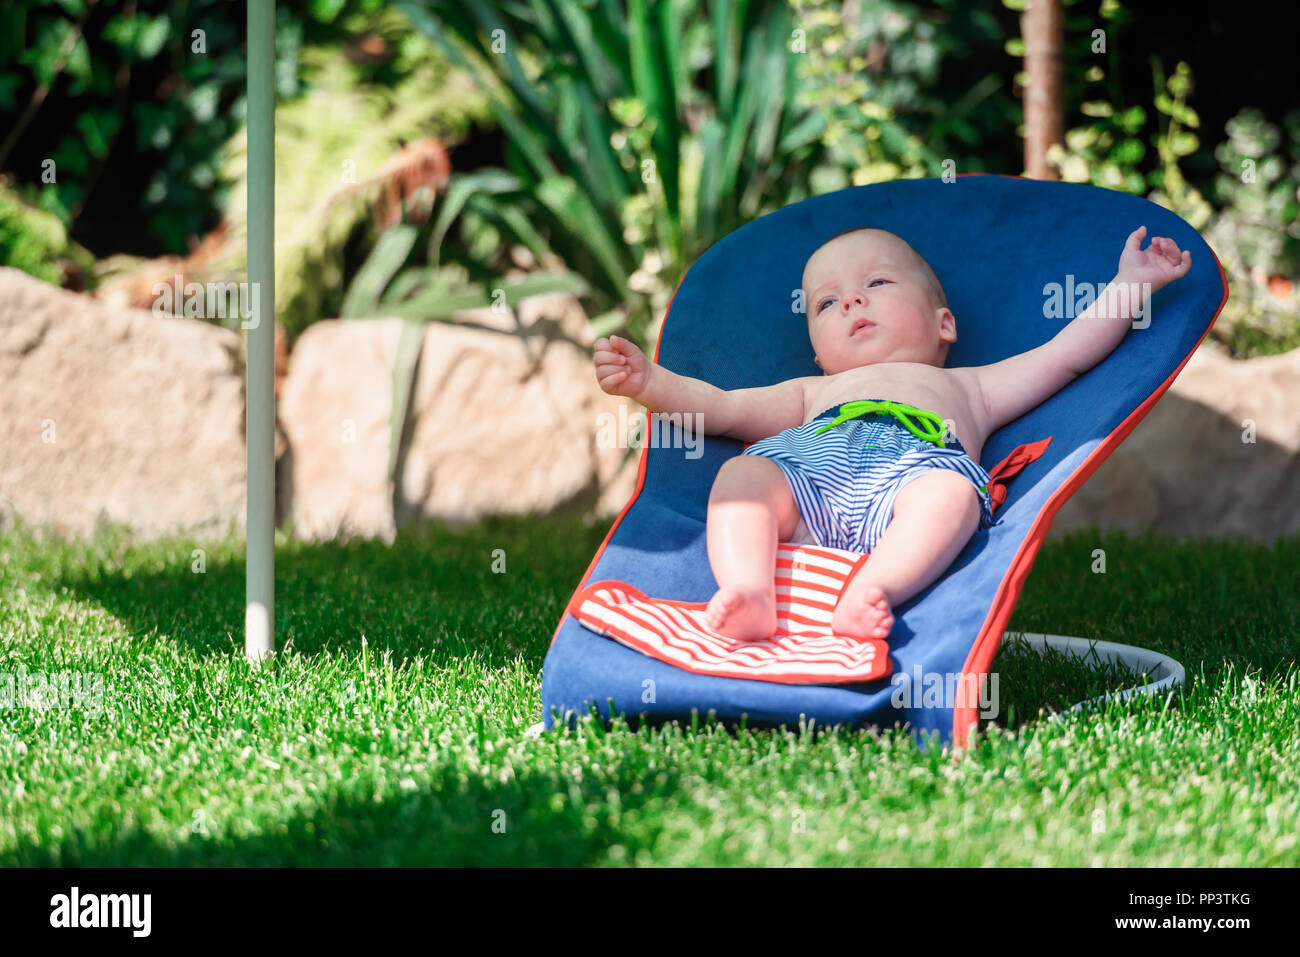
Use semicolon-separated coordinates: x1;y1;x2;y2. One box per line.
594;226;1191;640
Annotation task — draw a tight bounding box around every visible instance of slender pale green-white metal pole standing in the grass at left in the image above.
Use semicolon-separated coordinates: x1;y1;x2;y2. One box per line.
244;0;276;662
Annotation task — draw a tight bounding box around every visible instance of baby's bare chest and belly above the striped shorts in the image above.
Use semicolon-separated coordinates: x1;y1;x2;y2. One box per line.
803;363;988;462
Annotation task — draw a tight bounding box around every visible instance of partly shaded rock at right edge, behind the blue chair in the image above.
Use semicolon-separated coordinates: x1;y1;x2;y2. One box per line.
1048;345;1300;545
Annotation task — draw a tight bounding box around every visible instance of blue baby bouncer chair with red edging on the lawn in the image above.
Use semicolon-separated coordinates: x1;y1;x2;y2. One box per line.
542;176;1227;746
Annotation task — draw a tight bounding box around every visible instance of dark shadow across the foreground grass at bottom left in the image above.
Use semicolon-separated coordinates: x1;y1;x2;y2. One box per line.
5;733;677;867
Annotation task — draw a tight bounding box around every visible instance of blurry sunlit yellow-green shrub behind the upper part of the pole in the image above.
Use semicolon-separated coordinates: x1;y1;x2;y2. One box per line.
202;10;488;341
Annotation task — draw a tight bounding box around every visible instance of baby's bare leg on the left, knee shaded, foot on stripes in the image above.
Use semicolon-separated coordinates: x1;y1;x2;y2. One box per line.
705;455;800;641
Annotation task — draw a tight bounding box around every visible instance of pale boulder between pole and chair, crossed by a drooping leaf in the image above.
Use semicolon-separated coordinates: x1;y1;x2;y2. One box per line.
281;294;640;542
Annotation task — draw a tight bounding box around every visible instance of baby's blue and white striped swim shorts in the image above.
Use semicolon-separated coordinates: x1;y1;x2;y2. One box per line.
741;399;1001;554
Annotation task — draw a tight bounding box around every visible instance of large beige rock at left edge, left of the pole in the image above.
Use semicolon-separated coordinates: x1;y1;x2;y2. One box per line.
0;268;244;540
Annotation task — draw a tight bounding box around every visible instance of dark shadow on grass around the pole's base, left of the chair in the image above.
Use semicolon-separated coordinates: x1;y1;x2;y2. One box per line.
29;512;610;668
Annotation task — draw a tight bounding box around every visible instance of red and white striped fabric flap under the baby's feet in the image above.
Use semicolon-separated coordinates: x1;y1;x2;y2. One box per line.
568;542;891;684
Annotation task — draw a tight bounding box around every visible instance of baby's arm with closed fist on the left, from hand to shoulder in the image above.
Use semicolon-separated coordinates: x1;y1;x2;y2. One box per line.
593;335;805;442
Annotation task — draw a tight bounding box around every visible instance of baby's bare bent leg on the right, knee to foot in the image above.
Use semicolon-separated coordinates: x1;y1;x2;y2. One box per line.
831;468;980;638
